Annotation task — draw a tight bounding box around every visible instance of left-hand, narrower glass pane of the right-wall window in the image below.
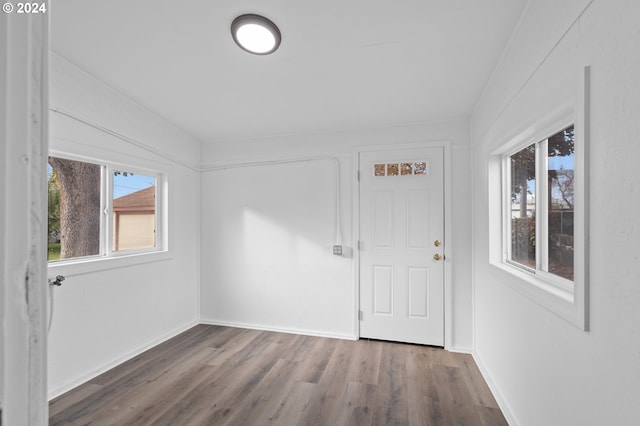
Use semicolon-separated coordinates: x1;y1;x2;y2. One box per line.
510;144;536;268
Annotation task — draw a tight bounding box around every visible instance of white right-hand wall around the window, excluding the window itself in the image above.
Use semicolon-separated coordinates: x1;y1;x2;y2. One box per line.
472;0;640;425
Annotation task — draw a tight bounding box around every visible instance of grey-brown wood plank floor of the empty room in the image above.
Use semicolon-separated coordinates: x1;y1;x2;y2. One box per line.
50;325;507;426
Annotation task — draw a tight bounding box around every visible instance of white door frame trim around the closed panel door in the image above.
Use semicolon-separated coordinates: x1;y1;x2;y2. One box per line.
352;141;453;350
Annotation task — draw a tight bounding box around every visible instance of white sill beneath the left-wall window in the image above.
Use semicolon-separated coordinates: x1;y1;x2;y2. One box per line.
47;251;173;277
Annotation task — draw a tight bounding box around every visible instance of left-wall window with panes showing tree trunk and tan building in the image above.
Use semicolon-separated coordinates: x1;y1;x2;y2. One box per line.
47;156;163;262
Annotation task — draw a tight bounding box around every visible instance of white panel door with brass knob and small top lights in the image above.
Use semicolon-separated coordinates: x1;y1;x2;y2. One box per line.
359;148;444;346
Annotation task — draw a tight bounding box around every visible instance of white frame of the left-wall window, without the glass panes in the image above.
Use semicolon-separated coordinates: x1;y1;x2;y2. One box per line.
48;151;170;275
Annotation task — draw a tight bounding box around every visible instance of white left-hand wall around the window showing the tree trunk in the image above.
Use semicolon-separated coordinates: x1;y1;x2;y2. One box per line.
48;55;199;397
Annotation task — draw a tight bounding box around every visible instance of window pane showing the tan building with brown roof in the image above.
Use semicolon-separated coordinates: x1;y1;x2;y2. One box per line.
112;171;156;251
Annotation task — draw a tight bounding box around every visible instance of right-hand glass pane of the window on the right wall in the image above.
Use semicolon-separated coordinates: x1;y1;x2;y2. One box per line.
547;126;574;280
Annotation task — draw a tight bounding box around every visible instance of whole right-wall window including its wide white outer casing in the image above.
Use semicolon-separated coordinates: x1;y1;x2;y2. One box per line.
487;67;590;330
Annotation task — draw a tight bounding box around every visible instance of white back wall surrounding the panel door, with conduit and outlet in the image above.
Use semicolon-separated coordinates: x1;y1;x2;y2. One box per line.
201;120;472;350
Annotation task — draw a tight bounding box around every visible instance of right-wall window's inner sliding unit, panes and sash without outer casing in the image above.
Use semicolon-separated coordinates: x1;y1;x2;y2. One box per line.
503;124;575;289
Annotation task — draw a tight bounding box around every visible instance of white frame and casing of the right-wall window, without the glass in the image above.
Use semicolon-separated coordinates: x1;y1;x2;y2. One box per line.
488;67;589;331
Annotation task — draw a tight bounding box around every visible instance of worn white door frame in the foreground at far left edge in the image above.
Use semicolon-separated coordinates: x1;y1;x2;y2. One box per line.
0;5;50;425
